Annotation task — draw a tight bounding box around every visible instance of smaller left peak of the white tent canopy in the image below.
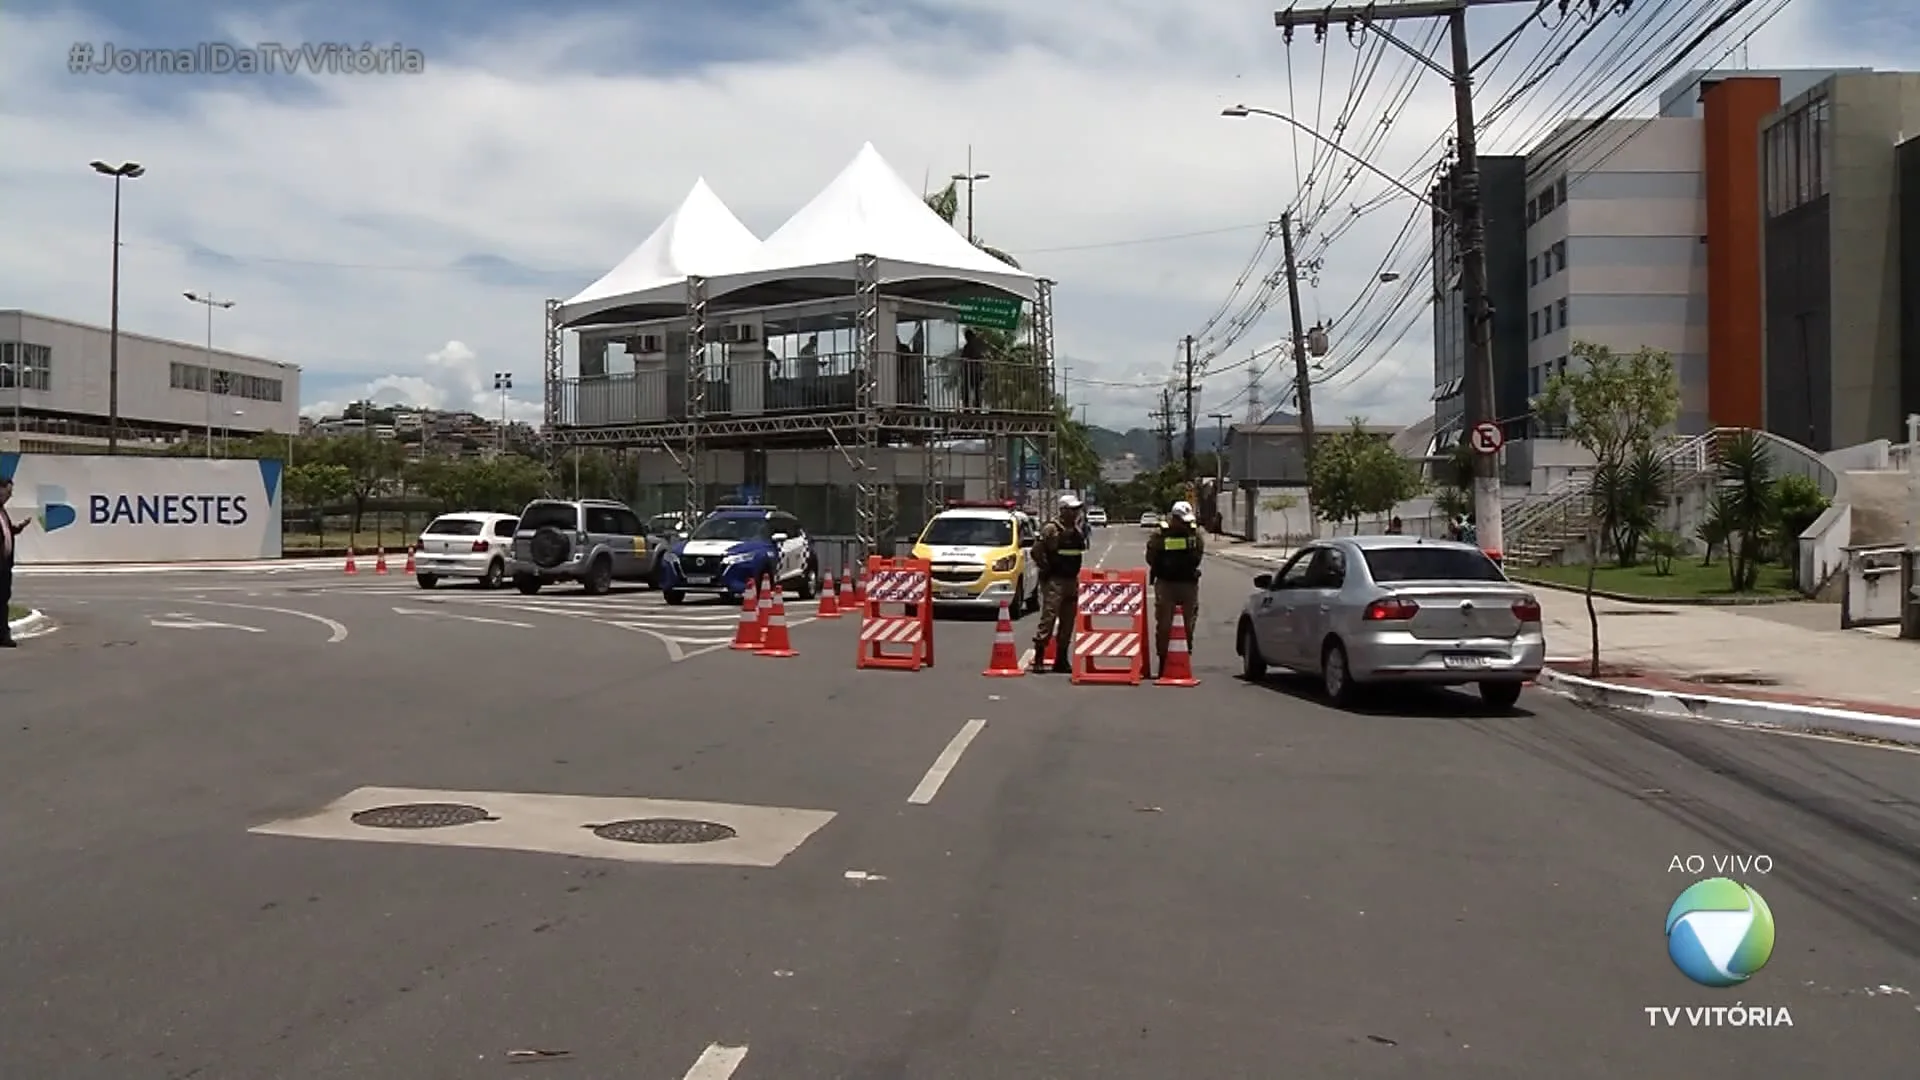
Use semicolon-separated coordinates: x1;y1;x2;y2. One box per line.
561;179;760;325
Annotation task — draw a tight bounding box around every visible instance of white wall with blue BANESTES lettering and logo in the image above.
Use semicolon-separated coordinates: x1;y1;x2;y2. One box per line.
0;454;282;563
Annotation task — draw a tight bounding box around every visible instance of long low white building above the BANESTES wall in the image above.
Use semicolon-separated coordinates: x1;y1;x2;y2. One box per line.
0;311;300;450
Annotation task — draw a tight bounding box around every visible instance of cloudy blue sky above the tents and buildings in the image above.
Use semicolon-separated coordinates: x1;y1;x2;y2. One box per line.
0;0;1896;427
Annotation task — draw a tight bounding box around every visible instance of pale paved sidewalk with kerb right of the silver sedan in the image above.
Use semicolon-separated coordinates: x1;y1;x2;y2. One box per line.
1534;588;1920;742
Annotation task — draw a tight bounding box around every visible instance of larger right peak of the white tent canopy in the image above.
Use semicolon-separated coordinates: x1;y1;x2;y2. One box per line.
591;142;1039;306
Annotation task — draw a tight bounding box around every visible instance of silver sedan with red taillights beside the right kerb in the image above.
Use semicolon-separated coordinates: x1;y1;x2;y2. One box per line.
1235;536;1548;707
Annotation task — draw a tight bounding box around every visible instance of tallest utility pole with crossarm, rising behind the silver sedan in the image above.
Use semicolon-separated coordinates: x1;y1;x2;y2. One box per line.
1273;0;1520;559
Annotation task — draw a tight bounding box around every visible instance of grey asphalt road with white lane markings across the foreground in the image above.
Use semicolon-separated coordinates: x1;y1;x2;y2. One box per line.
0;528;1920;1080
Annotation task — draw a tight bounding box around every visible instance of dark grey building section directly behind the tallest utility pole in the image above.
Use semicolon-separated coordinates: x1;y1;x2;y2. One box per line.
1432;156;1530;448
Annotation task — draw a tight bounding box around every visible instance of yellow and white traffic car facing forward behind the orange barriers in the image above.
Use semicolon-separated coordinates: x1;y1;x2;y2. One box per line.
914;502;1041;619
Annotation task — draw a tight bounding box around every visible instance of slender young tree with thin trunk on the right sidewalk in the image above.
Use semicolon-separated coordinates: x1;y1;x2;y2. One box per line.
1534;342;1680;678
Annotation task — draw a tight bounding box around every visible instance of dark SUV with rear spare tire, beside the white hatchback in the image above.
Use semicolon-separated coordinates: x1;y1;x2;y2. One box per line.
511;500;660;596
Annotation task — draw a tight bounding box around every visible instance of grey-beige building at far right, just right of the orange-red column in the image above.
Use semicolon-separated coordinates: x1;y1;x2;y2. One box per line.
1759;71;1920;452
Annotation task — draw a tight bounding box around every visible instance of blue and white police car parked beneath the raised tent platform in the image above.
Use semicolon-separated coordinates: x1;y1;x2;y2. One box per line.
660;505;820;603
